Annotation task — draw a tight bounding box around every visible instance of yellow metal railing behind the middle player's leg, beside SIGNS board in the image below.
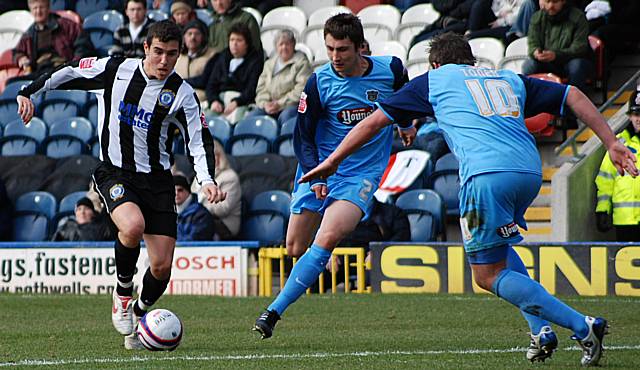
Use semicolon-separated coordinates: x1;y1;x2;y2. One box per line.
258;246;371;297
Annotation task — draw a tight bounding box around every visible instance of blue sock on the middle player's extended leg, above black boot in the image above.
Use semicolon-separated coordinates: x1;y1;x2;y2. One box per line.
267;244;331;315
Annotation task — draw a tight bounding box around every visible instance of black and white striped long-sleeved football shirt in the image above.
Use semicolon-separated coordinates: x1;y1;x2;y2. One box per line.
20;57;215;184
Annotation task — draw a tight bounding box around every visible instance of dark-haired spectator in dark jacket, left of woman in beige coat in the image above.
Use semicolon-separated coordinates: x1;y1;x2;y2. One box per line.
205;23;263;122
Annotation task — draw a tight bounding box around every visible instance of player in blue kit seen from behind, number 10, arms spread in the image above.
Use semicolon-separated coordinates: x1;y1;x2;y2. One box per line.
300;33;638;366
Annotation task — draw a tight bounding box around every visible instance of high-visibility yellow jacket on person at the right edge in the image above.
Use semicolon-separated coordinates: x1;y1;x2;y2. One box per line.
596;128;640;225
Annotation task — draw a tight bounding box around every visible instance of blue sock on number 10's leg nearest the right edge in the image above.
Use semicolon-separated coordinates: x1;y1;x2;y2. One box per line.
492;268;589;338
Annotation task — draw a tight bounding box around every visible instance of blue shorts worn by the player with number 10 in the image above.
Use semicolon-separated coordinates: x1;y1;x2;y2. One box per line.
460;172;542;263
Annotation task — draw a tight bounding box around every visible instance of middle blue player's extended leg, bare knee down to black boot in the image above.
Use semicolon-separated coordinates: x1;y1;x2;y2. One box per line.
253;200;362;339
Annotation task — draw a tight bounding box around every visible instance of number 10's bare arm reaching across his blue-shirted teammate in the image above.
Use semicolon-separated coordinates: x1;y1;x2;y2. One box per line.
298;109;391;183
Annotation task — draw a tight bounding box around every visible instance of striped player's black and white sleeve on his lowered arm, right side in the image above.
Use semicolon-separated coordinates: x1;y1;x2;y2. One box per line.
175;83;217;185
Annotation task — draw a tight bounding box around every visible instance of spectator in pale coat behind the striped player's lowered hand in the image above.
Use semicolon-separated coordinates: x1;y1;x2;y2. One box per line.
191;140;242;240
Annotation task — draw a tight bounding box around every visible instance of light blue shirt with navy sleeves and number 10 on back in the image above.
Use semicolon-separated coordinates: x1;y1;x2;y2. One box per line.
378;64;569;184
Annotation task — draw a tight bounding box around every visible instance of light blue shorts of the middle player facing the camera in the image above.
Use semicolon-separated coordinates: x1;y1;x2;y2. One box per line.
290;165;380;220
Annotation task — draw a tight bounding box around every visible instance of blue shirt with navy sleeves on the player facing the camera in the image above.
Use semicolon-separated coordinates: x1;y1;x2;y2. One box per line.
293;56;411;183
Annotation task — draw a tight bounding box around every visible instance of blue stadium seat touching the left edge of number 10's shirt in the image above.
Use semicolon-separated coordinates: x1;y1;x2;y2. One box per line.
428;153;460;216
